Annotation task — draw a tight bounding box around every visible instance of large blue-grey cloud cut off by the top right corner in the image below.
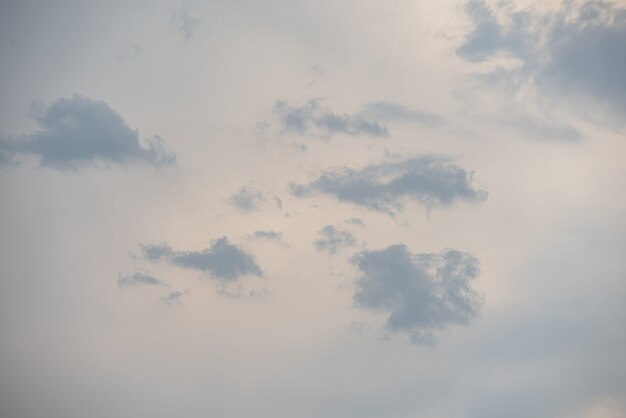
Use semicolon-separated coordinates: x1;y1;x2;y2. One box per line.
456;1;626;124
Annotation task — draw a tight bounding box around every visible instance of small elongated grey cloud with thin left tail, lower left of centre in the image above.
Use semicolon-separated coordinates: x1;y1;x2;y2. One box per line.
141;237;263;281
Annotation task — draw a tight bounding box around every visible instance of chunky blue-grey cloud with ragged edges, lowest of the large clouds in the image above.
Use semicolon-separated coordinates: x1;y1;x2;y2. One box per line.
350;244;483;342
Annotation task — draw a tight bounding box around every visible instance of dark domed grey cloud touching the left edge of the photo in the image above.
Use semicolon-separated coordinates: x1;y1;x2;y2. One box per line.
0;94;176;169
